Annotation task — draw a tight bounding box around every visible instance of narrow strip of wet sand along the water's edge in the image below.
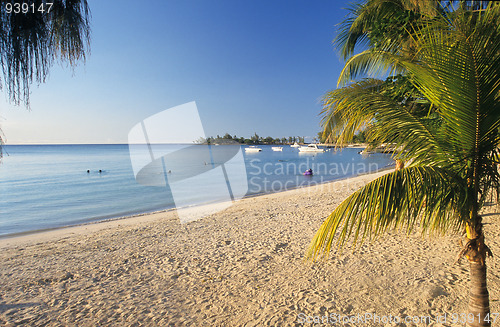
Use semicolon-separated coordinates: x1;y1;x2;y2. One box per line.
0;165;394;248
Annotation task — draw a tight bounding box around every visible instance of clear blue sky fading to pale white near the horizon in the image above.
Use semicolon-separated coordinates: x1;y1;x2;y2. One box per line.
0;0;356;144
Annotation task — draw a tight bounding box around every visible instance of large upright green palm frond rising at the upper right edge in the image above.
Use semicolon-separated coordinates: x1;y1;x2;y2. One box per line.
395;5;500;157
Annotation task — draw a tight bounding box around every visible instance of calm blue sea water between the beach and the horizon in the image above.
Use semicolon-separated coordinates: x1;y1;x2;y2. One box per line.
0;144;393;236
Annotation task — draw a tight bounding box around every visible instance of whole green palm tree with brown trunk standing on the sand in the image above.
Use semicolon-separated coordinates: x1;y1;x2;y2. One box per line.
307;5;500;326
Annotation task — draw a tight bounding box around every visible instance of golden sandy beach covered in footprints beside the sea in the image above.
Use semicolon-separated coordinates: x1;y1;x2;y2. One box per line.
0;172;500;326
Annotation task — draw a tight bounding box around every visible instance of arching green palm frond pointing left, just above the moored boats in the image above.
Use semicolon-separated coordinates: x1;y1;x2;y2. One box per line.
321;79;453;166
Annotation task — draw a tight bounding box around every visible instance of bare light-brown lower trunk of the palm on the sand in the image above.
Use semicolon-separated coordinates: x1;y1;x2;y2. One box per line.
467;261;491;327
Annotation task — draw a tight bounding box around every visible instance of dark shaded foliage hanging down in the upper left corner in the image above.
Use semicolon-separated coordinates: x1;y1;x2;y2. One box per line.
0;0;90;159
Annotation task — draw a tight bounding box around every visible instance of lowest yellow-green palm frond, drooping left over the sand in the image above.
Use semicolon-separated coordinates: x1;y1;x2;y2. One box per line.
307;167;468;260
